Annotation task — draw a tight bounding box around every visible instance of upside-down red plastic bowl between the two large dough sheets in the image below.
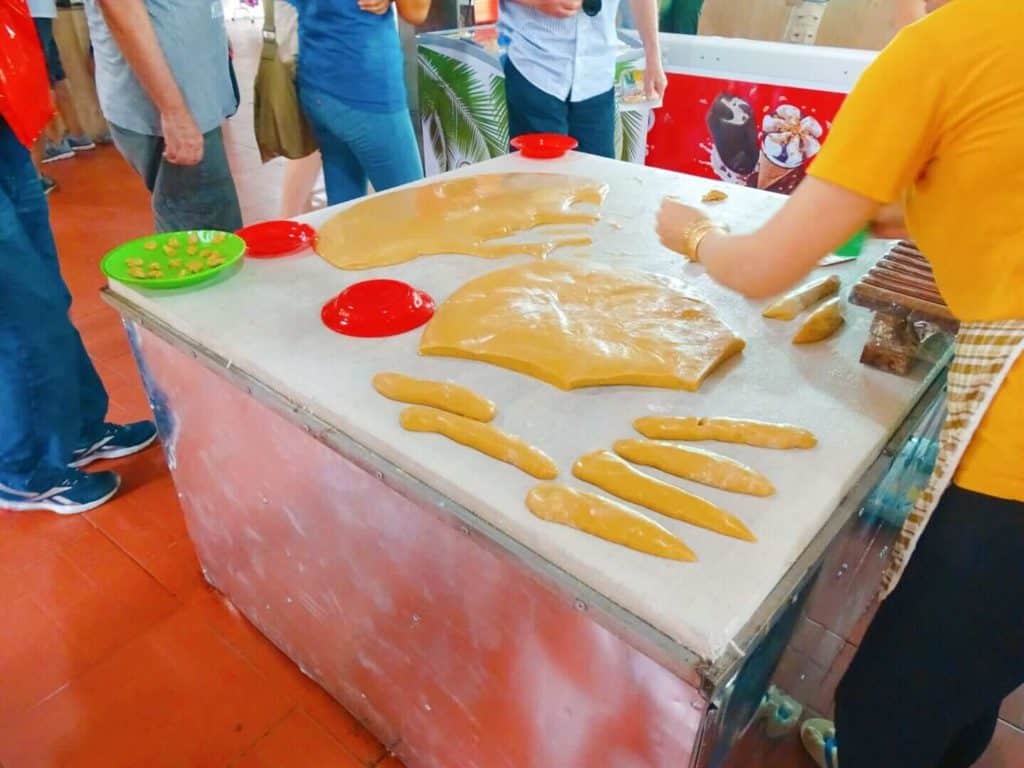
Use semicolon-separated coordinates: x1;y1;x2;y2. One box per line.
321;280;434;338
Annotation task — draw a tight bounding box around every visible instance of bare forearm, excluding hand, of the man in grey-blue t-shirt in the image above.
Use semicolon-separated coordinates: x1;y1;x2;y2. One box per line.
96;0;187;115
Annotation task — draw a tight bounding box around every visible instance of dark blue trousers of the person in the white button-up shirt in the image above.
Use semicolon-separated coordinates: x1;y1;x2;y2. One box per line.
505;57;616;160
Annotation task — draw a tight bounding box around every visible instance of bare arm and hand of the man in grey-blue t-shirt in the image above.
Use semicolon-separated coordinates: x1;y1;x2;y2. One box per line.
96;0;203;165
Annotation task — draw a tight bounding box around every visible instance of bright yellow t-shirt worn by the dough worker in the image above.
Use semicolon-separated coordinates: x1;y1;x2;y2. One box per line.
810;0;1024;501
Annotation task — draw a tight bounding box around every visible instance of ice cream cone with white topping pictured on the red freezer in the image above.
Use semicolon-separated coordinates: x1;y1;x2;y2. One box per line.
758;104;822;195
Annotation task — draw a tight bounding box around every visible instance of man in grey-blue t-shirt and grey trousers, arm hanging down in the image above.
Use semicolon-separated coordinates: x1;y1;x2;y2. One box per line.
86;0;242;231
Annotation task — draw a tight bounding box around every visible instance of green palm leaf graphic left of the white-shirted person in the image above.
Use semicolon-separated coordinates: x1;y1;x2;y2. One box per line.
417;47;508;171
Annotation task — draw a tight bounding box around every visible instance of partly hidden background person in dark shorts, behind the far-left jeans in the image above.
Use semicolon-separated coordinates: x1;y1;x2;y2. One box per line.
29;0;96;195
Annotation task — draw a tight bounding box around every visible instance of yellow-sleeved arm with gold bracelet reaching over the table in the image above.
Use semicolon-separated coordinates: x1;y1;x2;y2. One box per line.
657;20;947;298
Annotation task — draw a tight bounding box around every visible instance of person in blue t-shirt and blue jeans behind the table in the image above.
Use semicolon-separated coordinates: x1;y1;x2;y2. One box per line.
293;0;430;205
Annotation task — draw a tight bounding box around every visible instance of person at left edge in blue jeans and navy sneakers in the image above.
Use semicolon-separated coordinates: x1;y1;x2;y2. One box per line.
0;6;157;514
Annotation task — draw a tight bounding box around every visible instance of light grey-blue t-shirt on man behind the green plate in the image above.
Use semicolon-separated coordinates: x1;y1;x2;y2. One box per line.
85;0;235;136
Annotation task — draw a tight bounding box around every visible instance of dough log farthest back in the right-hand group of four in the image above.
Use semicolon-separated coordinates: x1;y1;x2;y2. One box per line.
633;416;818;449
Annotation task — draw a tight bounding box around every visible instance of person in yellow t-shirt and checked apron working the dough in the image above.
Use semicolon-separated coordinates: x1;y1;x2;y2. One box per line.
657;0;1024;768
